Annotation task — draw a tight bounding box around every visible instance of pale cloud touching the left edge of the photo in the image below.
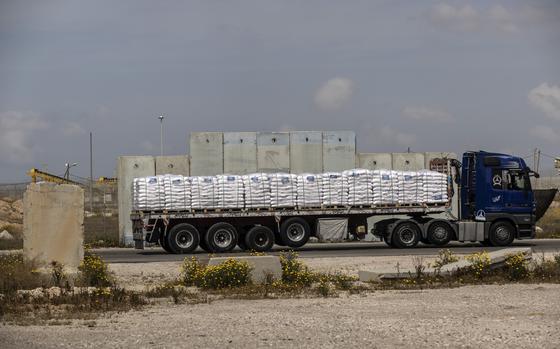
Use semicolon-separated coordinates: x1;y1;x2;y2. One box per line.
0;111;48;164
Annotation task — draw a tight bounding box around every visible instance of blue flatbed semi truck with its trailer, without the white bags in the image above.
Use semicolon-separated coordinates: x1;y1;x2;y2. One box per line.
131;151;557;254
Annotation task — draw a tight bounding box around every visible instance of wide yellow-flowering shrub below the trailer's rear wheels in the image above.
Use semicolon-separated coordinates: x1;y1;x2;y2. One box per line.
182;257;251;289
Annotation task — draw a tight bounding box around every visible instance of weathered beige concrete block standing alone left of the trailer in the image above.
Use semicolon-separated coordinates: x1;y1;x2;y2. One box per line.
23;182;84;271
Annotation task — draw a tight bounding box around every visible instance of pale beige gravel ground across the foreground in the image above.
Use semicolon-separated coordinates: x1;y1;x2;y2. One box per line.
0;284;560;349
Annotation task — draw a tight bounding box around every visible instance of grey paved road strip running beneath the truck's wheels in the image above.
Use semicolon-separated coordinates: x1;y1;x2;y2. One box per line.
96;239;560;263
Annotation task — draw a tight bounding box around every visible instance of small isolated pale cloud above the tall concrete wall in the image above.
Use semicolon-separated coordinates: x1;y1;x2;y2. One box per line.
315;78;354;111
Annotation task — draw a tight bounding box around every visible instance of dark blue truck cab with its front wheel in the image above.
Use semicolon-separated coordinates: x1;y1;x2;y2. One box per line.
460;151;548;246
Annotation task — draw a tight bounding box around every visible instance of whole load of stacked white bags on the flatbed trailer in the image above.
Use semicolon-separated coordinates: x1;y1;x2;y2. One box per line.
132;169;449;210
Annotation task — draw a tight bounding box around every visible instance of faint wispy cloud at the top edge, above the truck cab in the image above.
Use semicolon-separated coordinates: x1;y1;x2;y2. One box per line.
430;3;521;33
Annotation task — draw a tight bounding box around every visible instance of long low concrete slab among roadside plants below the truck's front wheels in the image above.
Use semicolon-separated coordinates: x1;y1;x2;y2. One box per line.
358;247;533;282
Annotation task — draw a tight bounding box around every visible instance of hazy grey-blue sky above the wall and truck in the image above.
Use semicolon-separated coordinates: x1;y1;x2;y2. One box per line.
0;0;560;183
